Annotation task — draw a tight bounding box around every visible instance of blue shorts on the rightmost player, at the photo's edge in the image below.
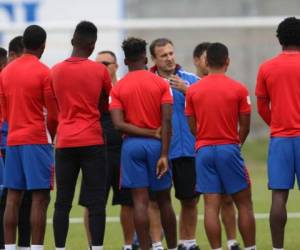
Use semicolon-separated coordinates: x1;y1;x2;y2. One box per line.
268;137;300;189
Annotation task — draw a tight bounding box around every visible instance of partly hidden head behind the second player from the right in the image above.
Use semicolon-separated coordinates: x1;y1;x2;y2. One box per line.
193;42;210;77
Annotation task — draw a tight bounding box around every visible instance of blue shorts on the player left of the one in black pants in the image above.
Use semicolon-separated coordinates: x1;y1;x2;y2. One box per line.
4;144;54;190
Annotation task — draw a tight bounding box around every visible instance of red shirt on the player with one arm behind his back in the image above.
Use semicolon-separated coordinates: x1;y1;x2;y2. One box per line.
109;70;173;129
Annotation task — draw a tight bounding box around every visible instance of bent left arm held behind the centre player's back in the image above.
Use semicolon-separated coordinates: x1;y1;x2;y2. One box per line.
110;109;160;139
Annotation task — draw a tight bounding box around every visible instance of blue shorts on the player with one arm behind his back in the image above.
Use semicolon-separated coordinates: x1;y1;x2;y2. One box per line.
121;137;172;191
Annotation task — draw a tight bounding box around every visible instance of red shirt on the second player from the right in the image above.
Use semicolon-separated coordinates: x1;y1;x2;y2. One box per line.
185;74;251;150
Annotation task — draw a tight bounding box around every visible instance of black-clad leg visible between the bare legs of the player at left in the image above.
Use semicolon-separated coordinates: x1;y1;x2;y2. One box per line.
18;191;32;250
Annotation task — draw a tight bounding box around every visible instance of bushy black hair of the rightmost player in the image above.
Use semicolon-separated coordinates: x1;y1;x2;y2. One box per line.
276;17;300;46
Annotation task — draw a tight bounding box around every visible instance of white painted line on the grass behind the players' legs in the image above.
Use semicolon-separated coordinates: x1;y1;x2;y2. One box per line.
47;212;300;224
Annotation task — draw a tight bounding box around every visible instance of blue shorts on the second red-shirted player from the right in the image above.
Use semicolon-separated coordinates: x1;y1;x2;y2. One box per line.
196;144;250;194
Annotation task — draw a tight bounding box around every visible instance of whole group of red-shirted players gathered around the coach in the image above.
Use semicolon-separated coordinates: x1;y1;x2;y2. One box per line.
0;17;300;250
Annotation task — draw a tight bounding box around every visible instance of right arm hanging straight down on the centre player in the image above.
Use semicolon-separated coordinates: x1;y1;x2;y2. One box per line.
156;104;172;179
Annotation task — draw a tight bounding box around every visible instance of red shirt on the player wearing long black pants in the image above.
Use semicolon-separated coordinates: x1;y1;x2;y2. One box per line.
52;57;111;148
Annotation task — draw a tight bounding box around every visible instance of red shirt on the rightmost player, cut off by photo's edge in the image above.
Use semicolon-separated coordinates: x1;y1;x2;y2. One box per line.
255;51;300;137
